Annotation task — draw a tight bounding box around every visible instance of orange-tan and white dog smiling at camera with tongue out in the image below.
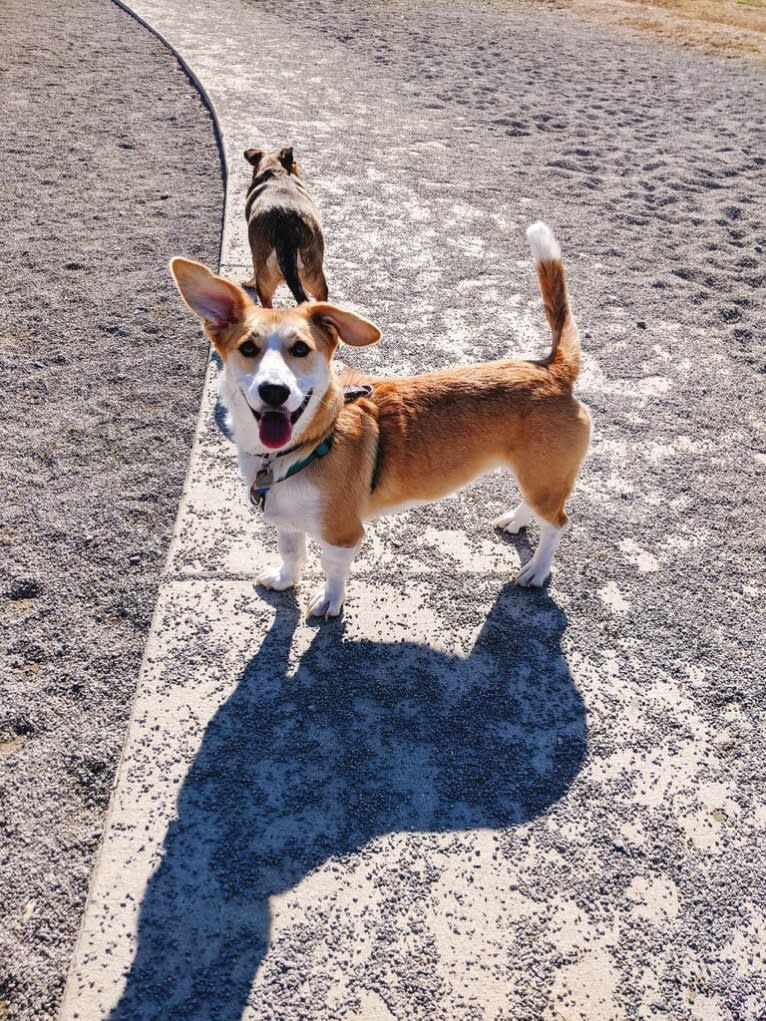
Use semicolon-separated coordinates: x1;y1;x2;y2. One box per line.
171;223;590;617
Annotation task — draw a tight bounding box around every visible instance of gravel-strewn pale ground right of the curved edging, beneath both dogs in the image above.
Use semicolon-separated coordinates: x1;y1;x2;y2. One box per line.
3;0;766;1021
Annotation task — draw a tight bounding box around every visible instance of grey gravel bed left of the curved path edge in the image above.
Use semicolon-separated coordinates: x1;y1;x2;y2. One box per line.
0;0;223;1021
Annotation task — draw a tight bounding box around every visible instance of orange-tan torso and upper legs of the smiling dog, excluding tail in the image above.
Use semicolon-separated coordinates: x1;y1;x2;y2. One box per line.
315;360;590;545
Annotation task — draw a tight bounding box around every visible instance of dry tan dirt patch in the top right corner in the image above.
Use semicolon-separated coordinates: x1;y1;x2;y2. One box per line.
552;0;766;61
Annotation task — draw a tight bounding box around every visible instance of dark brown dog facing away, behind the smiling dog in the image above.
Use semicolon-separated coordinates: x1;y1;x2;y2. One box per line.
245;145;327;308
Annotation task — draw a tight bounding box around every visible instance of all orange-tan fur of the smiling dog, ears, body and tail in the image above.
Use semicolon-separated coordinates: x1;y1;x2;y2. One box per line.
173;228;590;608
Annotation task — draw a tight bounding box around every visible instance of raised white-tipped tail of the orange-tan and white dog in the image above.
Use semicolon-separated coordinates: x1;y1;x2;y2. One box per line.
527;221;580;387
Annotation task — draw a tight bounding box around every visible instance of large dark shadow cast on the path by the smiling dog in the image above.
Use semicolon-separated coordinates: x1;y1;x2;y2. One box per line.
109;585;586;1021
